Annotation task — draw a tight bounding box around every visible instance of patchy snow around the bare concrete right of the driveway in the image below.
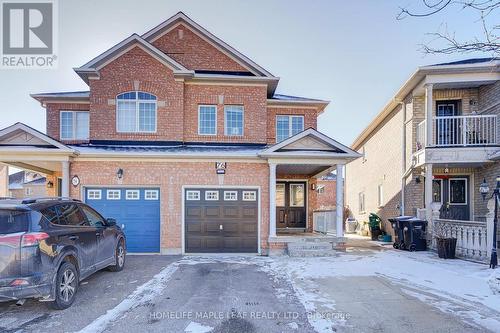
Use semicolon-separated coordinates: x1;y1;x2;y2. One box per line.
264;248;500;332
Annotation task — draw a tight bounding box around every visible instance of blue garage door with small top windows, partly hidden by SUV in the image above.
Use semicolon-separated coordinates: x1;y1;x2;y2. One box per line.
85;188;160;252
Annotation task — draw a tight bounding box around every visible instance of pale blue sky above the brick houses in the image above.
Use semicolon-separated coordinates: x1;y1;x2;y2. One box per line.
0;0;489;144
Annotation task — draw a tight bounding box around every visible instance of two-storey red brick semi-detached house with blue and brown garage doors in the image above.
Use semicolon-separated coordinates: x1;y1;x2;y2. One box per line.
0;13;359;254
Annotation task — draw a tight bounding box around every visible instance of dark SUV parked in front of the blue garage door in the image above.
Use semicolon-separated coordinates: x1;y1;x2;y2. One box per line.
0;198;126;309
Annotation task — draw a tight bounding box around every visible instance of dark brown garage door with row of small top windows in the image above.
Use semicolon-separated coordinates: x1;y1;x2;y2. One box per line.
184;188;259;253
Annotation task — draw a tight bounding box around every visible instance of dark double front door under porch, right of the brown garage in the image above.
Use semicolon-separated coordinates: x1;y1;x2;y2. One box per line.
276;182;307;228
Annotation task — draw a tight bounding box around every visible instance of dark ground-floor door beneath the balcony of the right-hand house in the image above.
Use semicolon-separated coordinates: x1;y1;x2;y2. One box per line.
433;176;470;220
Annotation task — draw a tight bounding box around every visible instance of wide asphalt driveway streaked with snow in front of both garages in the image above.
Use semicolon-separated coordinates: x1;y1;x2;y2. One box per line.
0;248;500;333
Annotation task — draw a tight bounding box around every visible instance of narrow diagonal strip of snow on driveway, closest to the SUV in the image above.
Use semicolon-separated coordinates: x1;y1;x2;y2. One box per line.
75;263;179;333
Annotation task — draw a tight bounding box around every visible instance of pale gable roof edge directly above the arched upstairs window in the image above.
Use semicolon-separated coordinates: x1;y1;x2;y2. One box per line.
74;34;194;83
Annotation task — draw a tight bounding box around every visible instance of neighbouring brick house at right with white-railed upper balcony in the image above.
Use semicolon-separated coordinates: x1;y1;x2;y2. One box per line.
346;58;500;259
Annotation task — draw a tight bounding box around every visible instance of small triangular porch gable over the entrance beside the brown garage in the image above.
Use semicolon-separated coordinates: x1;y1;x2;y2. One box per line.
259;128;361;159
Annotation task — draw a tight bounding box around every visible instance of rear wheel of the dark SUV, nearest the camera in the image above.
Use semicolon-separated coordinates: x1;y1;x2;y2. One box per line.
51;262;78;310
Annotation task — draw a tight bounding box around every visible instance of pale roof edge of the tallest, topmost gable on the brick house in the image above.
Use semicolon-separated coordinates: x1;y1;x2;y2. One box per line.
142;12;274;77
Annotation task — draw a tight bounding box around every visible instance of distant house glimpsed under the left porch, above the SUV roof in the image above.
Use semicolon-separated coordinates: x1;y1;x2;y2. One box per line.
8;171;47;198
